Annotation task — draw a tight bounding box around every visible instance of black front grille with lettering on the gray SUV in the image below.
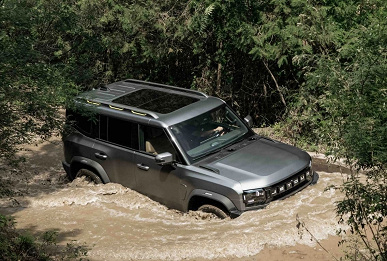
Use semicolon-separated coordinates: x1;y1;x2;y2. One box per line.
265;167;313;201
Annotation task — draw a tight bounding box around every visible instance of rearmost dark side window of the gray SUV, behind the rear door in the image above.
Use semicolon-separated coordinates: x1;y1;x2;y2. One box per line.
66;110;98;138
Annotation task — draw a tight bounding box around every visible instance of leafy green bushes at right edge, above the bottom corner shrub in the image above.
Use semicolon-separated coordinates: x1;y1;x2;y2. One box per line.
294;0;387;168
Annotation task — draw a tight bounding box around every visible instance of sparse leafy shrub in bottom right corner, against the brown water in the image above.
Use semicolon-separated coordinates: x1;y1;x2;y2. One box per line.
337;170;387;260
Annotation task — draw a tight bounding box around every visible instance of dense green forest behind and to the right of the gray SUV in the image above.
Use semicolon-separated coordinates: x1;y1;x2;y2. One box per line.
0;0;387;260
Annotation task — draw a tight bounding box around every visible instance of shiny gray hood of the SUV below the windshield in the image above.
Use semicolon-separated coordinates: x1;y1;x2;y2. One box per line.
206;138;310;190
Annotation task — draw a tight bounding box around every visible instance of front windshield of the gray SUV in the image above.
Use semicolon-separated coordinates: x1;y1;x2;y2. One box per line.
170;105;249;161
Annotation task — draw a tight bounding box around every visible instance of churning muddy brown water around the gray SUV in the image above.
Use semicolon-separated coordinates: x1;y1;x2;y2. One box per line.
0;140;342;260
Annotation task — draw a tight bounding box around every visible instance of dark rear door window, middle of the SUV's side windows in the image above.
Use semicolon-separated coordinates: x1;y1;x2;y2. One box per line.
99;115;138;150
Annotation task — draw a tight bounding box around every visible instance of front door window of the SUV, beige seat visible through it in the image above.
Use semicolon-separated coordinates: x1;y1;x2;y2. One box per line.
139;126;177;159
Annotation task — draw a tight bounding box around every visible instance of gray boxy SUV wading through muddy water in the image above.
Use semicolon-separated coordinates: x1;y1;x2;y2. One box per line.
63;80;318;218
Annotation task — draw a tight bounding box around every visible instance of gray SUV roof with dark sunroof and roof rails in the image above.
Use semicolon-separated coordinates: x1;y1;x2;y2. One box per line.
78;79;223;125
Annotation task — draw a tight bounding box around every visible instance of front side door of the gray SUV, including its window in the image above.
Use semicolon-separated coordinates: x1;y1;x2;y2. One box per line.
134;125;181;208
